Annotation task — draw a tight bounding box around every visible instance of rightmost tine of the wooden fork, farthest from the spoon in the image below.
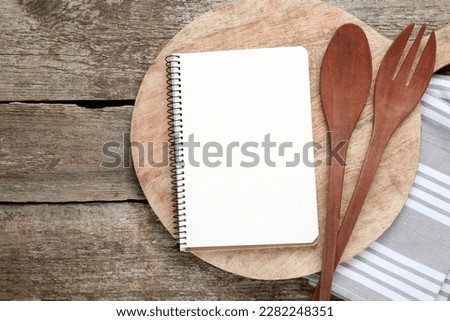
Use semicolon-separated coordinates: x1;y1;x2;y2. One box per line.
409;31;436;92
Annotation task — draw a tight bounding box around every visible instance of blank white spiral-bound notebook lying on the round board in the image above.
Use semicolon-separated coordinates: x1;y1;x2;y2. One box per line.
166;47;318;251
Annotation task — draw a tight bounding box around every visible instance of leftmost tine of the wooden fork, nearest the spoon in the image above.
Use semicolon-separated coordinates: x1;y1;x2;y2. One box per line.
377;23;414;79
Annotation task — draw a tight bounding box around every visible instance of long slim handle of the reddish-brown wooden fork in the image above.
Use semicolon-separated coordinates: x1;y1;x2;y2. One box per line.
311;128;391;300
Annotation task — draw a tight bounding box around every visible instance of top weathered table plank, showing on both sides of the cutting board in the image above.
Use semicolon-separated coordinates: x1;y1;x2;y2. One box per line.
0;0;450;101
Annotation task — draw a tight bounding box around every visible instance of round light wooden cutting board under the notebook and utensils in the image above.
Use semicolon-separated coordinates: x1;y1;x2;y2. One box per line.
131;0;450;280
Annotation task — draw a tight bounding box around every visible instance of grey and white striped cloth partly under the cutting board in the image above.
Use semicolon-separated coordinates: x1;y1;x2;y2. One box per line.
310;75;450;301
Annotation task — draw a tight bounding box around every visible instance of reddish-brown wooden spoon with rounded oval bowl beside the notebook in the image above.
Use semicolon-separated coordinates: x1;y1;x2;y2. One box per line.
313;24;372;300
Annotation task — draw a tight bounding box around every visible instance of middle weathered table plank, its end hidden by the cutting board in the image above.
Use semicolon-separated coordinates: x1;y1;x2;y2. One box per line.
0;104;145;202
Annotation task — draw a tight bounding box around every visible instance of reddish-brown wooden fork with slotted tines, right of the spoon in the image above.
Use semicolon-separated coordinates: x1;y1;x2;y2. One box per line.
312;24;436;300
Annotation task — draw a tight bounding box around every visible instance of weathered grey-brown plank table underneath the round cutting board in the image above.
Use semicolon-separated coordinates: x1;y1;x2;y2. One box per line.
0;0;450;300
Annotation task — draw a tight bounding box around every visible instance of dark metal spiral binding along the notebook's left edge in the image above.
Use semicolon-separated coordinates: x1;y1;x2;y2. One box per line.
166;55;187;249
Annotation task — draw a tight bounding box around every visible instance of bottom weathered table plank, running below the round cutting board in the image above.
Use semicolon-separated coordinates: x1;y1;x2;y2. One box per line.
0;203;320;300
